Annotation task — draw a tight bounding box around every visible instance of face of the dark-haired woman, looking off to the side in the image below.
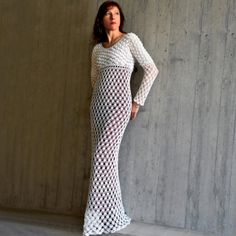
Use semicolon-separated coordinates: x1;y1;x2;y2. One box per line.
103;6;120;31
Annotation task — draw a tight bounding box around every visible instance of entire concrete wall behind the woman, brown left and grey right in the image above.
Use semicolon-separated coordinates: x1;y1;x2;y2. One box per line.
0;0;236;236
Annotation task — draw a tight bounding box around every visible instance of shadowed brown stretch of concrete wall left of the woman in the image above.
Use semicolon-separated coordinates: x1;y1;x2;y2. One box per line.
0;0;96;215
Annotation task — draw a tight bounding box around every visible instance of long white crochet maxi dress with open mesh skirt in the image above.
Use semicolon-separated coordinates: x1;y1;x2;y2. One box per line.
83;33;158;236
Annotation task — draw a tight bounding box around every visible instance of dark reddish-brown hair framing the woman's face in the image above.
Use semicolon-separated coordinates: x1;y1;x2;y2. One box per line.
93;1;125;43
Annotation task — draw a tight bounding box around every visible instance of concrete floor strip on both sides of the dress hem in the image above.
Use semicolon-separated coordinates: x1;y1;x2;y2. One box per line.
0;211;215;236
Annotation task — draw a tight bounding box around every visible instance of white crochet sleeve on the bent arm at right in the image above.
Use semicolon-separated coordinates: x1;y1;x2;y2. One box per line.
129;33;159;106
